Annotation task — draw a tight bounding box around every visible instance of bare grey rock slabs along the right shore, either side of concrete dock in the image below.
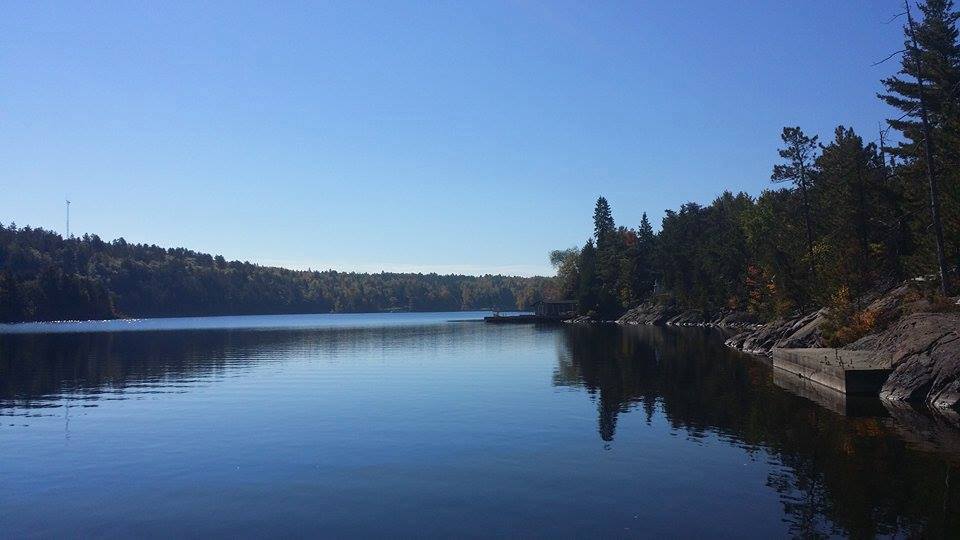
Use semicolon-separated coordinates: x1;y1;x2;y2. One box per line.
608;284;960;411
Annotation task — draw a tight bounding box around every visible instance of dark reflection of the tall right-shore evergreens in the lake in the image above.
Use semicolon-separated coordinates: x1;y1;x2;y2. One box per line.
554;327;960;537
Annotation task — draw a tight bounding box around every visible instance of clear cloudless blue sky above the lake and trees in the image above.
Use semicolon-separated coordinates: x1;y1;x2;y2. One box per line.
0;0;902;275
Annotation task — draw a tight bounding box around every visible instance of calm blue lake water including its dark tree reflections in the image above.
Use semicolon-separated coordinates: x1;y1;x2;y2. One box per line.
0;313;960;537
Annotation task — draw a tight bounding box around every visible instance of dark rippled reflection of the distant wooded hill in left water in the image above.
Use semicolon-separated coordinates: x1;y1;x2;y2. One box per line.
0;324;482;411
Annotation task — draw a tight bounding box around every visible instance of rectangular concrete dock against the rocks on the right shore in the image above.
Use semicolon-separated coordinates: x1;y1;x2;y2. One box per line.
773;349;891;396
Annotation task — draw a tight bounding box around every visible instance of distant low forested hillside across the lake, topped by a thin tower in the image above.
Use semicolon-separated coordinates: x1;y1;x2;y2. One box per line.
0;224;550;322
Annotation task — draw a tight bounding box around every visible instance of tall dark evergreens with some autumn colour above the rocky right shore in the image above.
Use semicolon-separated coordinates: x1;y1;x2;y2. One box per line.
551;0;960;318
